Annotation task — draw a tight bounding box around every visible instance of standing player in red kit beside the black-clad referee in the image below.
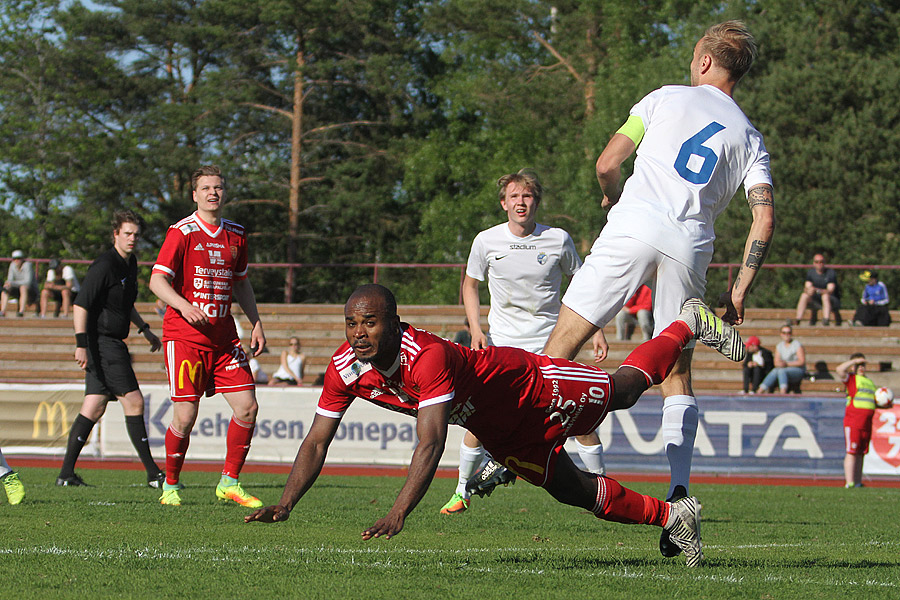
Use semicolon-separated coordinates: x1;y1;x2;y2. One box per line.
150;165;266;508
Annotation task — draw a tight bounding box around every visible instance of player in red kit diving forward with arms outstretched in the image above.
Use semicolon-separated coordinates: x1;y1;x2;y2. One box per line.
244;284;740;566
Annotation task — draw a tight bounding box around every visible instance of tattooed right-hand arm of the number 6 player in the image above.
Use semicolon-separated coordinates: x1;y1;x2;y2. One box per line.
720;184;775;325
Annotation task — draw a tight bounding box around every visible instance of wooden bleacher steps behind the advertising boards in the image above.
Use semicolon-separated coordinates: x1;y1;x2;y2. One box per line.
0;303;900;395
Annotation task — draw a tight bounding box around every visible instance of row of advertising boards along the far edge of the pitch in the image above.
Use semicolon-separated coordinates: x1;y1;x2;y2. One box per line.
0;384;900;476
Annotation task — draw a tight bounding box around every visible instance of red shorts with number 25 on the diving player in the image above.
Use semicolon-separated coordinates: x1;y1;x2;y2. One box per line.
478;356;614;486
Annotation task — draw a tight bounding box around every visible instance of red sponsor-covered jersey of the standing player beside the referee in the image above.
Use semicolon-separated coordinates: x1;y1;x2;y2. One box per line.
153;212;247;349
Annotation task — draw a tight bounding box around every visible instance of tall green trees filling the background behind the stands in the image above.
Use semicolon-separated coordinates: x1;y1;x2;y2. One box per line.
0;0;900;306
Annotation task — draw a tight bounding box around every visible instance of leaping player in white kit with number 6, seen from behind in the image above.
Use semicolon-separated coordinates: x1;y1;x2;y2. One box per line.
544;21;775;556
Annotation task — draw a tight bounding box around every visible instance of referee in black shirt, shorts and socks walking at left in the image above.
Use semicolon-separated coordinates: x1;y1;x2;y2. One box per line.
56;210;166;488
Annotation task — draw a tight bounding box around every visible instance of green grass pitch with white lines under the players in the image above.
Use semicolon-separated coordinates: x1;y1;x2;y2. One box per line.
0;466;900;600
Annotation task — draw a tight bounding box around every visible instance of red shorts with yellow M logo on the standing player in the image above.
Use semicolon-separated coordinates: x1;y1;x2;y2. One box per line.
165;340;256;402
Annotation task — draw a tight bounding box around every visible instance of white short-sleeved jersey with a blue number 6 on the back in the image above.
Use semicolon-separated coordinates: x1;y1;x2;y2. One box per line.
604;85;772;273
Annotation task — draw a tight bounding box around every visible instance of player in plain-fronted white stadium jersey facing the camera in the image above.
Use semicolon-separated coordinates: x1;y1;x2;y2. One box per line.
441;170;605;514
